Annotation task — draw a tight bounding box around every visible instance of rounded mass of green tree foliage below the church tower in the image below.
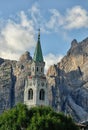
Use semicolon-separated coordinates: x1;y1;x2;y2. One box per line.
0;104;78;130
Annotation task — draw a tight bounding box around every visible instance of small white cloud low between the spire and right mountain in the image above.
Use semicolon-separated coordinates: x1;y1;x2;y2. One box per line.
44;53;63;72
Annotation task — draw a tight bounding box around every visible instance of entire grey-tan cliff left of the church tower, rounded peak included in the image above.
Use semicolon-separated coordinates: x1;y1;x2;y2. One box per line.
0;52;32;113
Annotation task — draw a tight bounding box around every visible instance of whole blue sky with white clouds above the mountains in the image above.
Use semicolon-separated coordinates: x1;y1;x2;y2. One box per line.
0;0;88;70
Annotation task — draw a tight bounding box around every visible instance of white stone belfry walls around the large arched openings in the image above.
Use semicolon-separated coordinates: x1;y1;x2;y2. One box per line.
24;78;48;108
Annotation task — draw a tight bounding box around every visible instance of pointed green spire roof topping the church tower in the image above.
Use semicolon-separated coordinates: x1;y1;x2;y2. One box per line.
33;29;43;62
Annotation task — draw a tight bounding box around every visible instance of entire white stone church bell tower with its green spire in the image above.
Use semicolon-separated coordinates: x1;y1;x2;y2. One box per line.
24;32;49;108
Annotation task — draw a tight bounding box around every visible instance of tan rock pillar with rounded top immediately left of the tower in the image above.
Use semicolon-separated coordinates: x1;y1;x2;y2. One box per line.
14;52;32;104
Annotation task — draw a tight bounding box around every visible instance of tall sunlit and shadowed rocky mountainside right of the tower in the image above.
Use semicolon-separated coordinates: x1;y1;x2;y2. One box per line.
47;38;88;121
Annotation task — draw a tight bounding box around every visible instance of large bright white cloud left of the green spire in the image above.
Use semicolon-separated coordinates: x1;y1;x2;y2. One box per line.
0;11;35;59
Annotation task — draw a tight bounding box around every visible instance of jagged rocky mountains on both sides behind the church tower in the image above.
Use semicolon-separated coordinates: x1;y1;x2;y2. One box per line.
0;38;88;122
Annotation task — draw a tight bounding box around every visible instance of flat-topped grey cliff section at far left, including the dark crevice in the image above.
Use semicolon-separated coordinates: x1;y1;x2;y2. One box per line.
0;59;16;113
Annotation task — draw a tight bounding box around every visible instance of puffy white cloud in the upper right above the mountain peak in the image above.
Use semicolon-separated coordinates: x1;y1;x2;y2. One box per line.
46;6;88;32
